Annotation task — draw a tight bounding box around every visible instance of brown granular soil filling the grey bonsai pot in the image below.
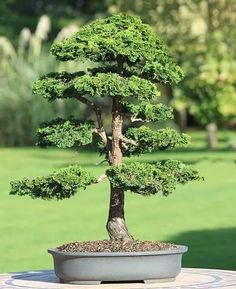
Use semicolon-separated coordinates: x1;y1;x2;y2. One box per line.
57;240;178;252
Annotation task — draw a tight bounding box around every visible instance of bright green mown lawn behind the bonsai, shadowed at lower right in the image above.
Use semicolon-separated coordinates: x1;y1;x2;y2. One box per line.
0;129;236;272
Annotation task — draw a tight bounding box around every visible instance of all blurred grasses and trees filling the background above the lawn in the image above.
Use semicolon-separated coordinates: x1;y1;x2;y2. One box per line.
0;0;236;148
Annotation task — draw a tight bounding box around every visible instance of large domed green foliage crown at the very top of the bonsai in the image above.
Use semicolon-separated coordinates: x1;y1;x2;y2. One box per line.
51;14;182;83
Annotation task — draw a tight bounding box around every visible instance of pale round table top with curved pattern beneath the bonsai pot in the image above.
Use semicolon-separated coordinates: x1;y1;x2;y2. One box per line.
0;268;236;289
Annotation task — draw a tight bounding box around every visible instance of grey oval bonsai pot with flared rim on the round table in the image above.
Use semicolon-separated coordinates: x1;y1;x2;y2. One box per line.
48;246;188;284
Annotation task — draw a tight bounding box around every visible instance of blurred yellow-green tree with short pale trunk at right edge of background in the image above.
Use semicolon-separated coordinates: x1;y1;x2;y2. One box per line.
171;0;236;148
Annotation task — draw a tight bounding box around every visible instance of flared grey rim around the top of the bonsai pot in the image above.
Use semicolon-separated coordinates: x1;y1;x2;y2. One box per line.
47;245;188;257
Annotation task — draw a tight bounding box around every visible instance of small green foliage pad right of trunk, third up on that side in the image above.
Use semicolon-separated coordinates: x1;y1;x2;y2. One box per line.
124;101;174;122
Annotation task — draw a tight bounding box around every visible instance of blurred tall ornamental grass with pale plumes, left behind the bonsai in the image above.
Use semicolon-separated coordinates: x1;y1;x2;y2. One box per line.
0;16;85;146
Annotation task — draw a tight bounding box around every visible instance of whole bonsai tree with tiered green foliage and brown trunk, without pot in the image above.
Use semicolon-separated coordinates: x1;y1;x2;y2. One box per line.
11;14;199;242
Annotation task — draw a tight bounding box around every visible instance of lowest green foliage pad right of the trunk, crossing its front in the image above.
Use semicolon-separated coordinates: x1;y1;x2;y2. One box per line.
106;160;200;196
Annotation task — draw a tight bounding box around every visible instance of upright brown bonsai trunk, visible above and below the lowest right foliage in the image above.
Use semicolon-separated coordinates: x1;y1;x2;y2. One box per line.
106;98;133;241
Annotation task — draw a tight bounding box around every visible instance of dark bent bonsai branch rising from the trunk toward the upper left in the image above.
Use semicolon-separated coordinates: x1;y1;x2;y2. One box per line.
75;95;107;144
